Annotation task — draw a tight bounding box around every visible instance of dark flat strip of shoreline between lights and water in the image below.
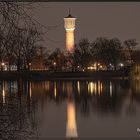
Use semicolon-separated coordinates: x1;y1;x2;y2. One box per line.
0;71;130;80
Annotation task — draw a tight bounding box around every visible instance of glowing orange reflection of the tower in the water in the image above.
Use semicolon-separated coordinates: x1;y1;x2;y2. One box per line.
66;83;78;138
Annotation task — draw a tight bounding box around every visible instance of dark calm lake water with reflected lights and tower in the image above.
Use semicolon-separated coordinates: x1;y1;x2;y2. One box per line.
0;80;140;140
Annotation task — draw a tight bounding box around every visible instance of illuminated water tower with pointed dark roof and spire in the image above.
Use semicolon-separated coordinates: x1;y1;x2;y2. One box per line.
64;10;76;53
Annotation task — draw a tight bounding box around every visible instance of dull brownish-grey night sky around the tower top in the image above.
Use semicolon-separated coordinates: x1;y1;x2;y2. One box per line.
29;2;140;50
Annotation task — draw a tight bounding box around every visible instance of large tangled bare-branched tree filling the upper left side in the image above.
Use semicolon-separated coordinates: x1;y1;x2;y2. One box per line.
0;2;42;71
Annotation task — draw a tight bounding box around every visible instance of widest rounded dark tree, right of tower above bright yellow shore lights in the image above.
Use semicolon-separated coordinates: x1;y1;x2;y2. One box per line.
91;37;122;70
